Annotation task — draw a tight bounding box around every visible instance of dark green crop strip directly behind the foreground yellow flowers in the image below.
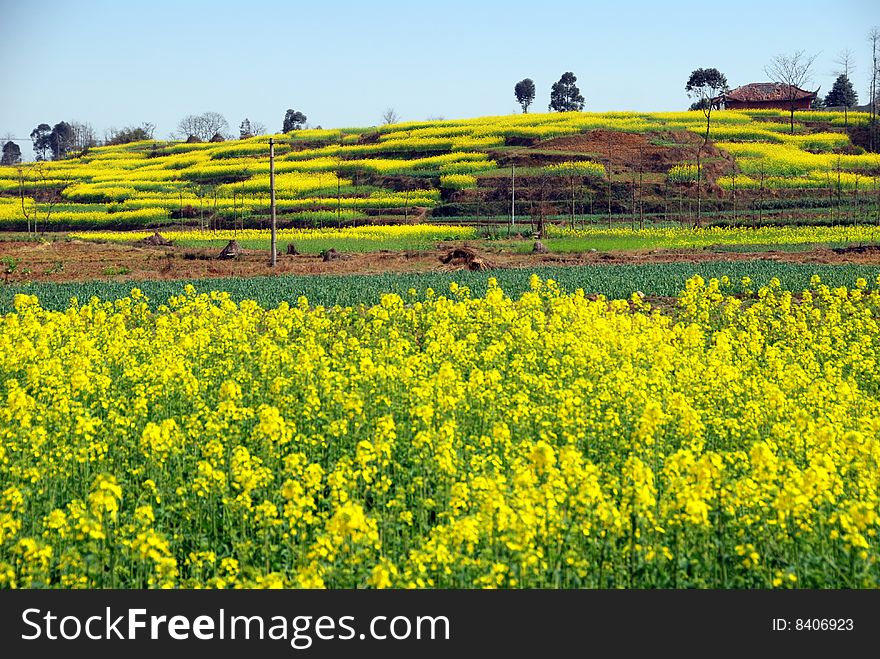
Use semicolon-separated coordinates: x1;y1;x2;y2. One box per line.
0;260;880;313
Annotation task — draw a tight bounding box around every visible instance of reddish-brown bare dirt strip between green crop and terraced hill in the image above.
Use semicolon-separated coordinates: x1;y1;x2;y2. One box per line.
0;241;880;283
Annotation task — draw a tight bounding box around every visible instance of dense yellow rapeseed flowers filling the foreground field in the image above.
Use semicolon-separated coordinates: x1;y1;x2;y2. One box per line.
0;277;880;588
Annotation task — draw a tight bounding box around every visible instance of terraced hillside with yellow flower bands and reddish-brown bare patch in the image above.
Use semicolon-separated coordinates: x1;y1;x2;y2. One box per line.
0;111;880;231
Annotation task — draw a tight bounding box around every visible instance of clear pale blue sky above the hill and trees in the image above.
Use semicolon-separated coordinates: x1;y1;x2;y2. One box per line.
0;0;880;154
